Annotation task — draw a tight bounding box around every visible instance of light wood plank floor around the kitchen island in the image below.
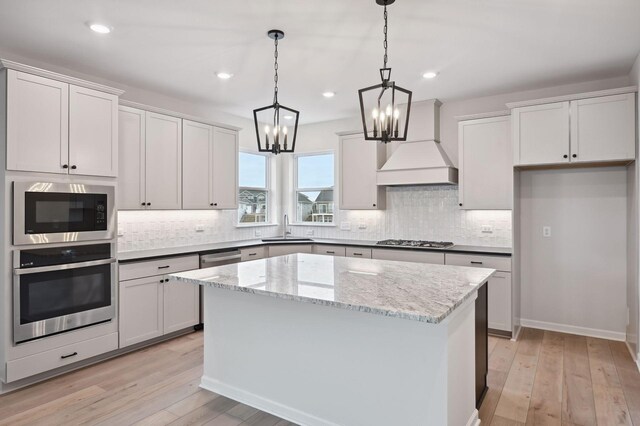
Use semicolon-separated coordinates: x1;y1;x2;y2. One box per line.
0;329;640;426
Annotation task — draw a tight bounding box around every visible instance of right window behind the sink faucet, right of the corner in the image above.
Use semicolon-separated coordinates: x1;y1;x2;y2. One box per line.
295;154;334;223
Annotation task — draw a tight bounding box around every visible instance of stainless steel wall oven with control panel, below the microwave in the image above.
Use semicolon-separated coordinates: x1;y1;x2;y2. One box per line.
13;243;116;343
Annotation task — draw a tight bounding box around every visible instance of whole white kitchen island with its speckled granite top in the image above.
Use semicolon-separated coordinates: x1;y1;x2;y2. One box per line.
170;254;494;426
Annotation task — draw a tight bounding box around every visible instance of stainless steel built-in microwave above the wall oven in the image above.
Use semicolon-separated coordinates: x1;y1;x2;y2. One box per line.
13;182;115;245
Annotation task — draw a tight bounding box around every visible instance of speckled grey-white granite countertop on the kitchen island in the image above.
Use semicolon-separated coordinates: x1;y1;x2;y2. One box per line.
169;254;495;324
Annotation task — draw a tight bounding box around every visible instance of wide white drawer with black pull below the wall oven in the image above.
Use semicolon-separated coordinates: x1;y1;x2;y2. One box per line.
7;333;118;383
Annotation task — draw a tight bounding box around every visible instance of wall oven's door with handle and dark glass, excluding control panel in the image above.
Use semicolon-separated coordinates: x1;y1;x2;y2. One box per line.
13;258;116;343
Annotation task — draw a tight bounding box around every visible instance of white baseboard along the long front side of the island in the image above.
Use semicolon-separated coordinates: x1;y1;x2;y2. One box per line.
200;376;339;426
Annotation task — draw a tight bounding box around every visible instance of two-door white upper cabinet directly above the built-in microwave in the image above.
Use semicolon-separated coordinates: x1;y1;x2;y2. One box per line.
6;69;118;177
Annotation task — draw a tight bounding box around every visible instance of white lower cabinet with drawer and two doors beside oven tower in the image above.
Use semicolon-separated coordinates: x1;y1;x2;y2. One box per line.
119;256;200;348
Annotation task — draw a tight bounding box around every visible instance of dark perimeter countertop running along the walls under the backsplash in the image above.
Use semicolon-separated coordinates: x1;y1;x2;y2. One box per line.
118;238;511;262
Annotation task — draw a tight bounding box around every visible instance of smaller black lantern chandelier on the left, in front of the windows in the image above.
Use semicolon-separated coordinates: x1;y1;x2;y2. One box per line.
253;30;300;154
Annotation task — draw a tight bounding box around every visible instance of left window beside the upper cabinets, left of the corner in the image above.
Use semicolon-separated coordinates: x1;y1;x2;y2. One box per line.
238;152;269;224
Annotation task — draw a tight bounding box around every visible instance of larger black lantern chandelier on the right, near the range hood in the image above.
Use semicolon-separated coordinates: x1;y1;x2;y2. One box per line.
358;0;411;143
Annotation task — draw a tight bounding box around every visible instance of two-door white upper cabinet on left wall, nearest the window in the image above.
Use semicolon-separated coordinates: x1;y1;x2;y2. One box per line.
182;120;238;209
